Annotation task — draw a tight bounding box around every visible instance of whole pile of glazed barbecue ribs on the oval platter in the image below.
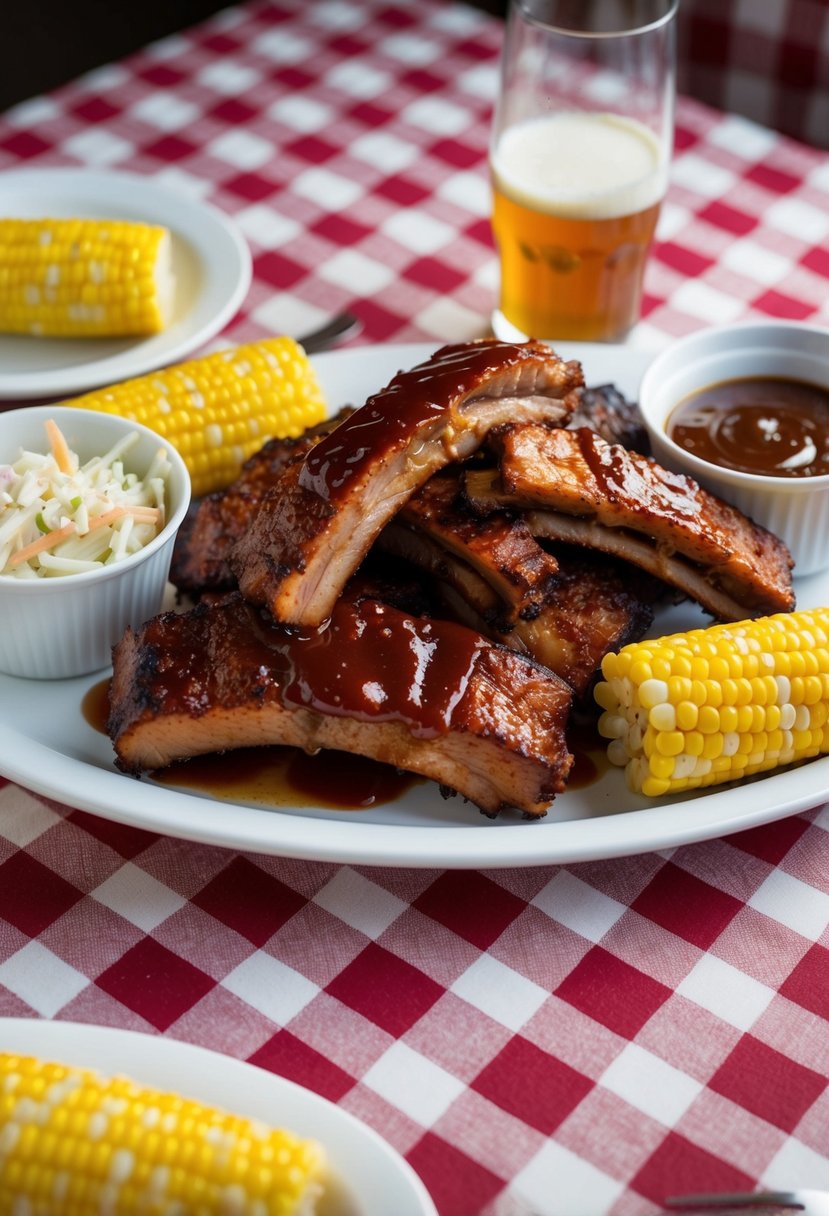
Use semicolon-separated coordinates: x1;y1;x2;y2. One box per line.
107;339;794;817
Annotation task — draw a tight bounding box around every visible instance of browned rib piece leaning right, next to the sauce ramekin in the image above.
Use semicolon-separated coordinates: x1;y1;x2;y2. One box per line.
464;423;795;620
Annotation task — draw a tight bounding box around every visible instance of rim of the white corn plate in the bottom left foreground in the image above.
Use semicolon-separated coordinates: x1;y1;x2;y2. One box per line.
0;1017;438;1216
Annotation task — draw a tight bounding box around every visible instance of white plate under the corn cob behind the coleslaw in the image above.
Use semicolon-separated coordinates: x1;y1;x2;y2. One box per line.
0;169;250;400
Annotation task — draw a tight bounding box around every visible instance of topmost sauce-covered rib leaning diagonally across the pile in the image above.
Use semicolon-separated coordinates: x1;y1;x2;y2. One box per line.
230;339;582;625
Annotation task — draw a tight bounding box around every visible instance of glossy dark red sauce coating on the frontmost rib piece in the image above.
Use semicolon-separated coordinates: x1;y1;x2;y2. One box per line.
122;597;489;738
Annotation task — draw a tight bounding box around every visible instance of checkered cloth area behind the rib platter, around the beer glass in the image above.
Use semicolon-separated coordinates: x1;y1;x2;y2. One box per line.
0;0;829;347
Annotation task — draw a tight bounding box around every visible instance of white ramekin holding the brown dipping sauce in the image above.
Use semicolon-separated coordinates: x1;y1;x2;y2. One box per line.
639;321;829;578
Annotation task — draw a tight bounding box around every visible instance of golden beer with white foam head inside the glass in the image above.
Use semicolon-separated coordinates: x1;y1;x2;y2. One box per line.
492;112;665;342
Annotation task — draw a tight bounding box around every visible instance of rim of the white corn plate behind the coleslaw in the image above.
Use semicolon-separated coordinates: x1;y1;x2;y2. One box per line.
0;165;253;401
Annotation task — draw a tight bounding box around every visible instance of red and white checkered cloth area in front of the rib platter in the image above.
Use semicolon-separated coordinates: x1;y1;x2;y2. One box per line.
0;784;829;1216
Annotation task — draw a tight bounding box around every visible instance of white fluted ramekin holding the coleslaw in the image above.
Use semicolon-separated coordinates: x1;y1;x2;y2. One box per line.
0;405;191;680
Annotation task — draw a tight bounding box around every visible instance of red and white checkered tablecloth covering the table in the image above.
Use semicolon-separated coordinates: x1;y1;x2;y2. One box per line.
0;0;829;1216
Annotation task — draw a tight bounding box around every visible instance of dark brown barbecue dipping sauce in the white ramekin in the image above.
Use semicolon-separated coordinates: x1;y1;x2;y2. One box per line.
667;376;829;477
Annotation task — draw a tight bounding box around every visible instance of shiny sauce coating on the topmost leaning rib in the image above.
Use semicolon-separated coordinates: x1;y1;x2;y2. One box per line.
299;342;542;507
